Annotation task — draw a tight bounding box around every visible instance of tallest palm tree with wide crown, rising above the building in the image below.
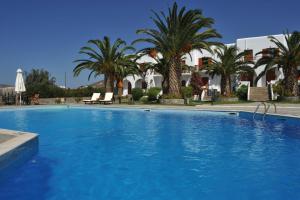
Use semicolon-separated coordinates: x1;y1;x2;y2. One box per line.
134;3;221;97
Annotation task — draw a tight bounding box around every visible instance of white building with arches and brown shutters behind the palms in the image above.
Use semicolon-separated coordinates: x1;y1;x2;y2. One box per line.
123;34;300;95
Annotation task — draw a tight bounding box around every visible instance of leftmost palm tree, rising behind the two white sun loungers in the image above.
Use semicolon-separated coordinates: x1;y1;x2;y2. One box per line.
73;36;135;92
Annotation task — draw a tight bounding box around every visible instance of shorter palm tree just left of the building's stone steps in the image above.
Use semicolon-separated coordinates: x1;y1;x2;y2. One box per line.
203;45;254;96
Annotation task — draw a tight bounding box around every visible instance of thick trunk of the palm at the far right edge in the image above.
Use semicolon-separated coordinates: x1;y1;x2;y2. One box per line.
284;67;299;96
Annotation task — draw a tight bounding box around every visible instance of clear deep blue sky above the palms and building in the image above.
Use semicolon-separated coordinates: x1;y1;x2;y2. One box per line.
0;0;300;87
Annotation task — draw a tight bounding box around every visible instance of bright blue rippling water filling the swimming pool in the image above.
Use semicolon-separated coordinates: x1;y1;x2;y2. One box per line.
0;107;300;200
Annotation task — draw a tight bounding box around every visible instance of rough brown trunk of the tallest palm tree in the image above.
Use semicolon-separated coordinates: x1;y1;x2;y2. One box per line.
168;59;180;98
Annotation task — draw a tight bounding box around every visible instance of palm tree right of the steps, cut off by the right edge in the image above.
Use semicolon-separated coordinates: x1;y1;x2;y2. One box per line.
255;31;300;96
